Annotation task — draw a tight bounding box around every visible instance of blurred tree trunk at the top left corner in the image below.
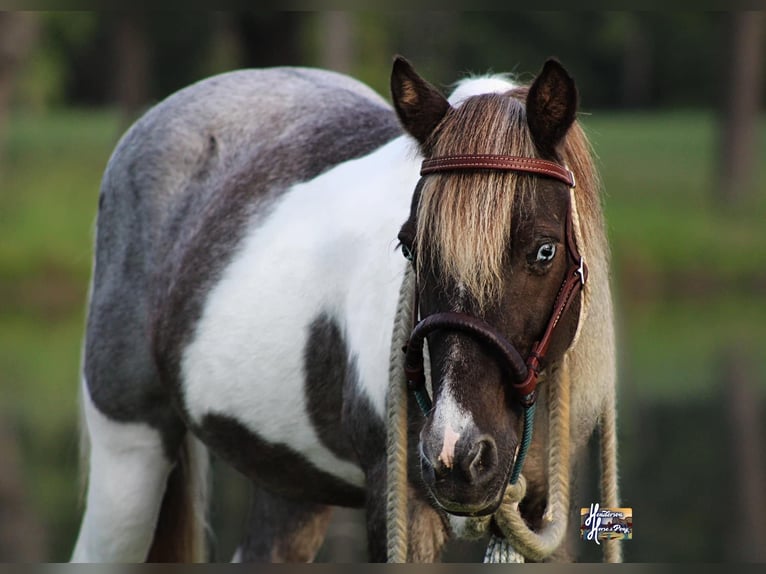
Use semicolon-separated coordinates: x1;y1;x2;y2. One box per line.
0;11;38;161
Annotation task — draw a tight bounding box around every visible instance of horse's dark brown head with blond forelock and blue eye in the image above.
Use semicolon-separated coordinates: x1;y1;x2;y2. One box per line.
391;58;584;515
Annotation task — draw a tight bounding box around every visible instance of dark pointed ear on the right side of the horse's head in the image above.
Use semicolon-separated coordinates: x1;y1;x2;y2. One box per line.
527;59;577;157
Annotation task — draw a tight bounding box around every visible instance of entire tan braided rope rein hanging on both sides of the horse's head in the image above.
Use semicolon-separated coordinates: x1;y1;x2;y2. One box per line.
386;265;622;563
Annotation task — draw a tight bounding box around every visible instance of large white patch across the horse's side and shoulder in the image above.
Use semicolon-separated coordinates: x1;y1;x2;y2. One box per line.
181;137;419;485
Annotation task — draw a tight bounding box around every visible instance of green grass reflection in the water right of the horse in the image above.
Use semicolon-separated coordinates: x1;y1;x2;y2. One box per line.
618;296;766;403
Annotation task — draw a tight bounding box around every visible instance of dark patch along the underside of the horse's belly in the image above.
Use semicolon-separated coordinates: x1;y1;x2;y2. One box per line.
194;414;364;507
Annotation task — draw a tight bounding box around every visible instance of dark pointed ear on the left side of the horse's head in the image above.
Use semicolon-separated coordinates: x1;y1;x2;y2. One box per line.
391;56;450;152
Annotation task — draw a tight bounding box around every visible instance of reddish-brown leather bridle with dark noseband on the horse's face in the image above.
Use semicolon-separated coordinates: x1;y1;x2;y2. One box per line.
404;155;588;413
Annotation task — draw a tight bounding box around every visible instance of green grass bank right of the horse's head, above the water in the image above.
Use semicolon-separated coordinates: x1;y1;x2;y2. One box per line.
587;113;766;291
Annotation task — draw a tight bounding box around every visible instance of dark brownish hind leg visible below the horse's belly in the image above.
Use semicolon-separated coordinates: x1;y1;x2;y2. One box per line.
234;485;332;562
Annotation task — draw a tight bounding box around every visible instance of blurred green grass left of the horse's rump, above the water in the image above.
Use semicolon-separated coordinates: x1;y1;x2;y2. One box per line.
0;112;119;278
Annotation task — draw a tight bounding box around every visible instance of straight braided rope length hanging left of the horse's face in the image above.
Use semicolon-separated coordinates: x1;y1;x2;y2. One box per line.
386;265;415;563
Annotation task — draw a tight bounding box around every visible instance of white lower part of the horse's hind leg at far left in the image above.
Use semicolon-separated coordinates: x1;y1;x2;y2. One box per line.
72;381;172;562
